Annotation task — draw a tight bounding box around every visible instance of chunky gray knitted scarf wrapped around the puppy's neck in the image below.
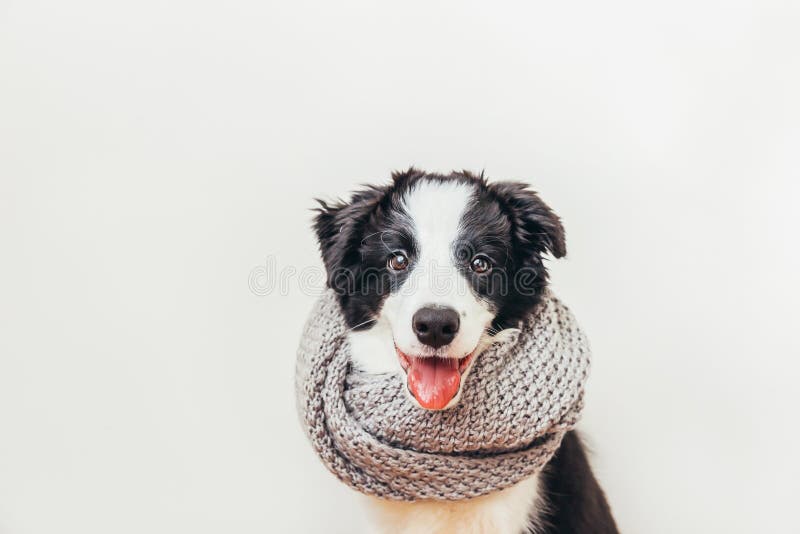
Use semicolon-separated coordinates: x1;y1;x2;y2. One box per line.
296;291;590;501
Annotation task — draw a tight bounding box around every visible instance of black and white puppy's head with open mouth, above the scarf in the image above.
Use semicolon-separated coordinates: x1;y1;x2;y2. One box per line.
314;168;566;410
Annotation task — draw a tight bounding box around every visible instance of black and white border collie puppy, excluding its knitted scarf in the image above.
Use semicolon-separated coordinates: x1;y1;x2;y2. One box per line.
314;168;617;534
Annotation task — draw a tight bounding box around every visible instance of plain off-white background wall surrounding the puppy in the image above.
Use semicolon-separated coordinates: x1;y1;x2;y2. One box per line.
0;0;800;534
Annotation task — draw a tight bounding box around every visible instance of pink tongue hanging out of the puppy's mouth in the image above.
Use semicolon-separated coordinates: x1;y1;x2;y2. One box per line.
408;358;461;410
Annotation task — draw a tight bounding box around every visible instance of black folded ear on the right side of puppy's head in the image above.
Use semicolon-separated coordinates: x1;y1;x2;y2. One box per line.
489;182;567;258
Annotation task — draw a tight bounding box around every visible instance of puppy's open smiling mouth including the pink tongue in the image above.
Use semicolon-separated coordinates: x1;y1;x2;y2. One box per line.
395;345;475;410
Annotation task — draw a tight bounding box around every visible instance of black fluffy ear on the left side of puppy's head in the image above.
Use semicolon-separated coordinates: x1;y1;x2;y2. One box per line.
314;187;385;282
